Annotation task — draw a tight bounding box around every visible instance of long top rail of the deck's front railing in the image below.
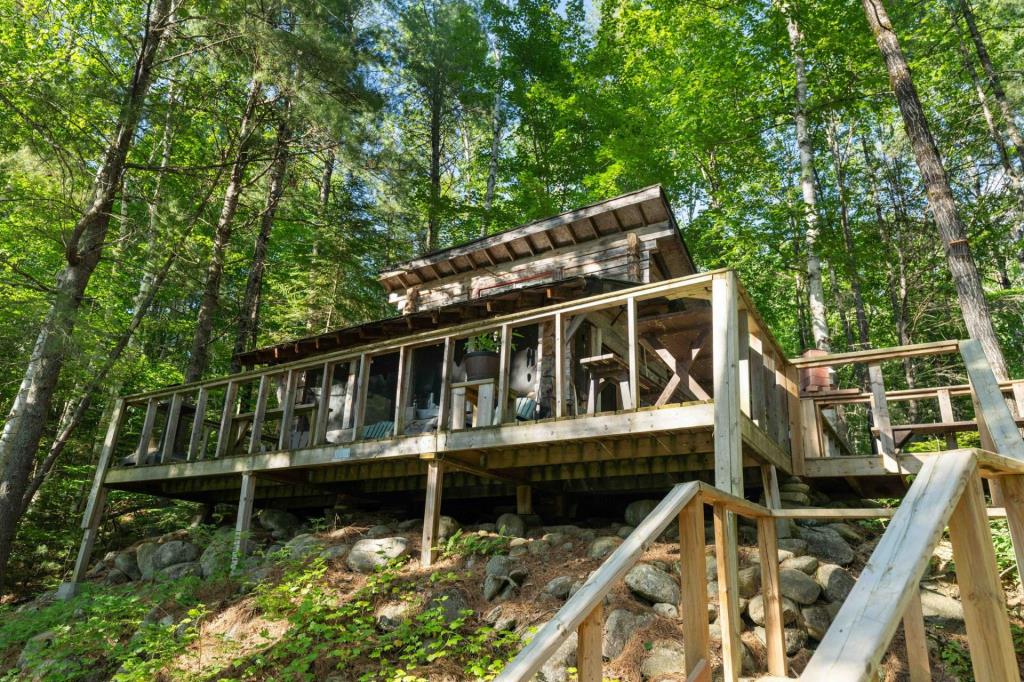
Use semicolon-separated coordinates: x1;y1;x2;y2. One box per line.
119;268;729;402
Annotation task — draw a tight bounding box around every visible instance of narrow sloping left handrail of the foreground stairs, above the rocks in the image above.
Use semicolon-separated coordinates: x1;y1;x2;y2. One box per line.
496;482;707;682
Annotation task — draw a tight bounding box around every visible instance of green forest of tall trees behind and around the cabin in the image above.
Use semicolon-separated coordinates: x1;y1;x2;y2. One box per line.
0;0;1024;593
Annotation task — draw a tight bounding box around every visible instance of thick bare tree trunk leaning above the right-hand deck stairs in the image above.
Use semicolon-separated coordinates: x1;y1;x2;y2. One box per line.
862;0;1008;380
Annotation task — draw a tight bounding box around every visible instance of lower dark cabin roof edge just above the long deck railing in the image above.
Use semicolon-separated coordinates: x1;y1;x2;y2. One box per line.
237;276;636;367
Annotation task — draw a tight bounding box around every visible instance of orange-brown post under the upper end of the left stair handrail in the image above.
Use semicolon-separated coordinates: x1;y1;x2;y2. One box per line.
678;497;709;679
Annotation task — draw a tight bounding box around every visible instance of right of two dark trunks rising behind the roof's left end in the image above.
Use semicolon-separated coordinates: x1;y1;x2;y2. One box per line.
231;112;291;372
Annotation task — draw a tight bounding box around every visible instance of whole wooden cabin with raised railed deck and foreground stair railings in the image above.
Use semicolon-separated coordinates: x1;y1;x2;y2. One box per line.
60;186;1024;681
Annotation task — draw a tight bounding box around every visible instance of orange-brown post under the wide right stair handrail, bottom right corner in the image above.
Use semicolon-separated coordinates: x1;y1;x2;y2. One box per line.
949;473;1020;681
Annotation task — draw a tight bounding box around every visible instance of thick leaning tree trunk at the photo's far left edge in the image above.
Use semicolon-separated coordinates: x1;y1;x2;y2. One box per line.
0;0;171;586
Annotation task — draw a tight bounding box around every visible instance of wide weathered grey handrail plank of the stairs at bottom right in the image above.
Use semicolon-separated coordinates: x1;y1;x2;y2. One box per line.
803;451;974;682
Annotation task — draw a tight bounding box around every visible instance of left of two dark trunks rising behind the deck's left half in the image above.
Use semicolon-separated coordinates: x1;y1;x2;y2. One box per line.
185;75;263;383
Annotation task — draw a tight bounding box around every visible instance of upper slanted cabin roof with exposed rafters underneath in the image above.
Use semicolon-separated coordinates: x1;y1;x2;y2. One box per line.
379;184;696;293
